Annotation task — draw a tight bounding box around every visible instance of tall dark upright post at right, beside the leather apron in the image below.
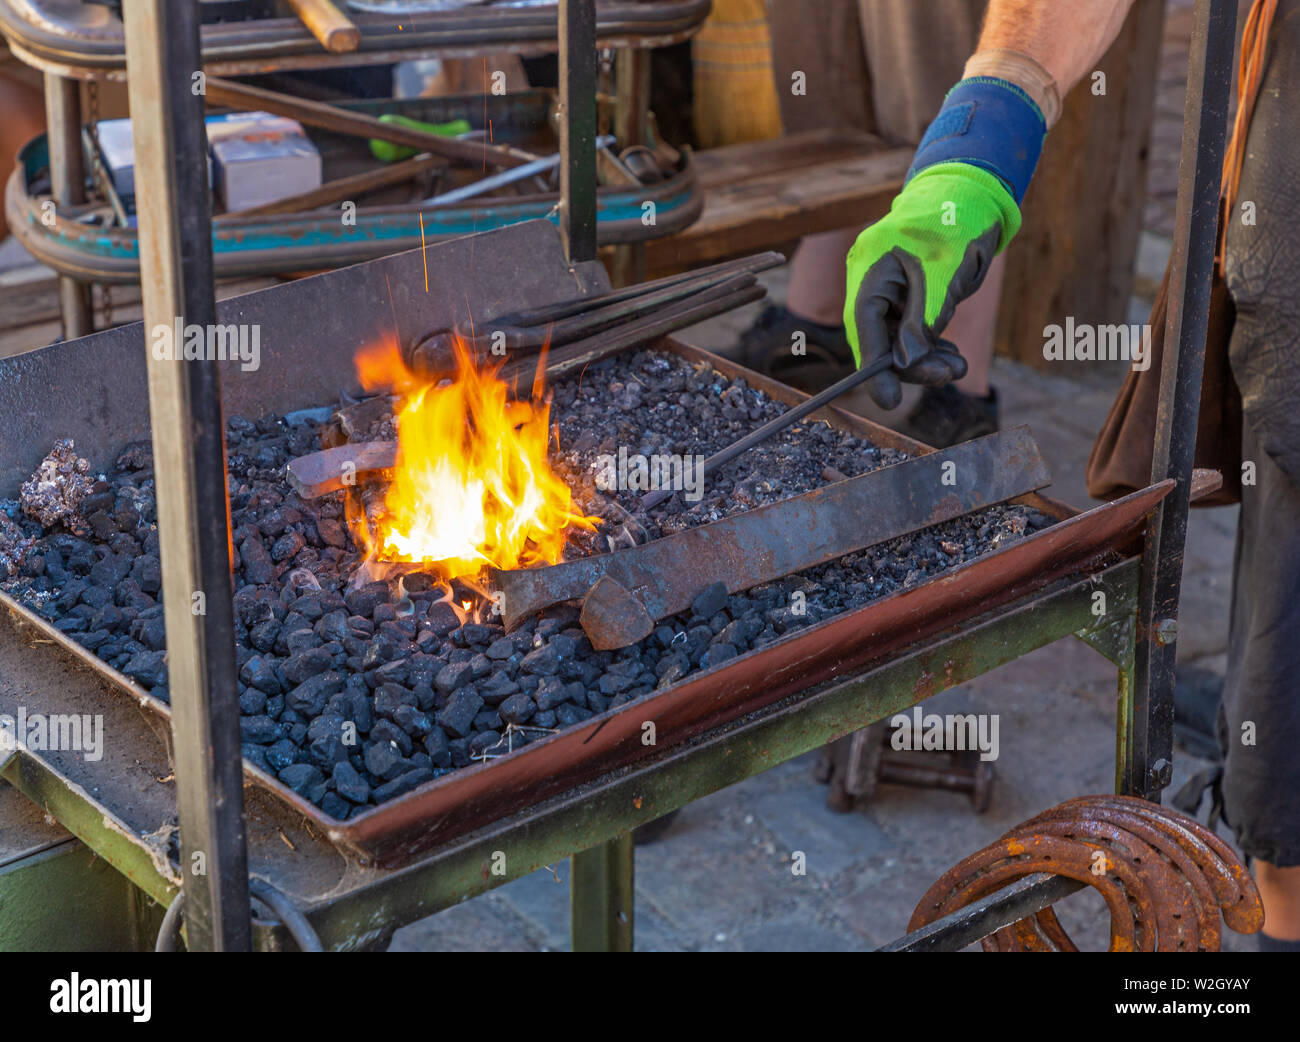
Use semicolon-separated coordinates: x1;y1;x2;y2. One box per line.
1123;0;1236;799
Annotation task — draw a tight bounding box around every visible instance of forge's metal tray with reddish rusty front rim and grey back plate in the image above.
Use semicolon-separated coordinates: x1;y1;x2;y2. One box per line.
0;222;1171;867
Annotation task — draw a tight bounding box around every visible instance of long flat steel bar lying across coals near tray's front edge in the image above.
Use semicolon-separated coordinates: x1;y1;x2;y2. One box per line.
493;426;1050;647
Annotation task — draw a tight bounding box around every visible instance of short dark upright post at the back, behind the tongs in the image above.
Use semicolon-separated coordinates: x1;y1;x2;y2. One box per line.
559;0;597;264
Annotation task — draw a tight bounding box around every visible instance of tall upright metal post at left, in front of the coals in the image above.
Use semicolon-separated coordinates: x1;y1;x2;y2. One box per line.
124;0;251;951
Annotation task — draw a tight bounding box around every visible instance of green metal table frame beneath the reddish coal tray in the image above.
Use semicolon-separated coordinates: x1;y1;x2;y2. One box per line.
0;559;1139;951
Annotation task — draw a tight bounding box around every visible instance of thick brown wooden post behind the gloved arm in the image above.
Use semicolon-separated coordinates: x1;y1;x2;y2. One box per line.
996;0;1165;368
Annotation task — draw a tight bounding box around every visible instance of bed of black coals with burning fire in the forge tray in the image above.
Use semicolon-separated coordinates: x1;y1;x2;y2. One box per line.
0;270;1057;821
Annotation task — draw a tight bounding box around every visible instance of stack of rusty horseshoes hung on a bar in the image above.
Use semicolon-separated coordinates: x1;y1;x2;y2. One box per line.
907;795;1264;951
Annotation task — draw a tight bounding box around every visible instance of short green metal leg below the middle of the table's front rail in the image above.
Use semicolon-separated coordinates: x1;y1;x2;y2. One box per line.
569;833;636;951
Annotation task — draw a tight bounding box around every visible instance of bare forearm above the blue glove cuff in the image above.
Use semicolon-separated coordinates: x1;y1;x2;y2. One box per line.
975;0;1134;97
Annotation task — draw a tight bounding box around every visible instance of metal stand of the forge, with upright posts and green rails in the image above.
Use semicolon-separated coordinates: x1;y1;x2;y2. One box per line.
0;0;1236;951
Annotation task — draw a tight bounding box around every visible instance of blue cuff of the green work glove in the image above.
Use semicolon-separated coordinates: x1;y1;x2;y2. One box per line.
905;75;1048;207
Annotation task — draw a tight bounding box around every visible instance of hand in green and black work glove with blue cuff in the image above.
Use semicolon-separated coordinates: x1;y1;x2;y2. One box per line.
844;77;1047;409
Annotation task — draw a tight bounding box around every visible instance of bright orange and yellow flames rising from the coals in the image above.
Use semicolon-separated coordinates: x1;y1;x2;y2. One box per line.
340;332;599;579
